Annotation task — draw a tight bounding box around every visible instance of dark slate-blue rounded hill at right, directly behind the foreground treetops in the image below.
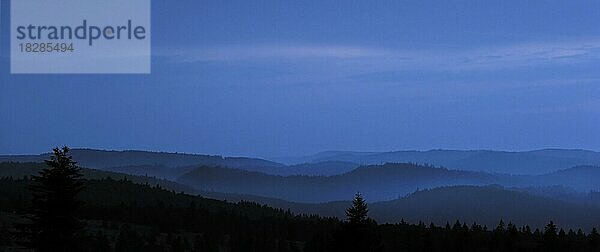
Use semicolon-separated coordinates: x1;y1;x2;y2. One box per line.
371;186;600;228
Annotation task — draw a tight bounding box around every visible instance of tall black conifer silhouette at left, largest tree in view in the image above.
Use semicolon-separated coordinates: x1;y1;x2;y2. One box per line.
27;146;83;251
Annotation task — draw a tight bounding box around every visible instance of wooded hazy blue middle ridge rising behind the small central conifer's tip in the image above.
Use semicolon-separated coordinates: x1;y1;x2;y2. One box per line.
177;164;520;202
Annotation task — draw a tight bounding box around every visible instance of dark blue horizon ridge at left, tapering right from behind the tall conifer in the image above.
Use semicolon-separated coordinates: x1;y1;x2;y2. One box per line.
0;149;359;180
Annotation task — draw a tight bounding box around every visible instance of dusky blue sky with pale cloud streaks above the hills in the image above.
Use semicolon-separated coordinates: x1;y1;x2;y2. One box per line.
0;0;600;157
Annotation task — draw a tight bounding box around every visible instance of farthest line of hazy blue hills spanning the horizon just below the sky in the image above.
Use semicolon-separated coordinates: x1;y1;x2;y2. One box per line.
0;149;600;177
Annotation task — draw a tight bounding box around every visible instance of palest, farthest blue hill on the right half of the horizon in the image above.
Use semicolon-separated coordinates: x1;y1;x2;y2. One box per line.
280;149;600;174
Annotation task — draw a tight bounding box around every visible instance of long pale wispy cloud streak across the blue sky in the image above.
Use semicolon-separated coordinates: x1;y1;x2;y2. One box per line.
159;39;600;71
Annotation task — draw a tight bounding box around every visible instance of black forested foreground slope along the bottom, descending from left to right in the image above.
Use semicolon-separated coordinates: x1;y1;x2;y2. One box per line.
0;174;600;252
